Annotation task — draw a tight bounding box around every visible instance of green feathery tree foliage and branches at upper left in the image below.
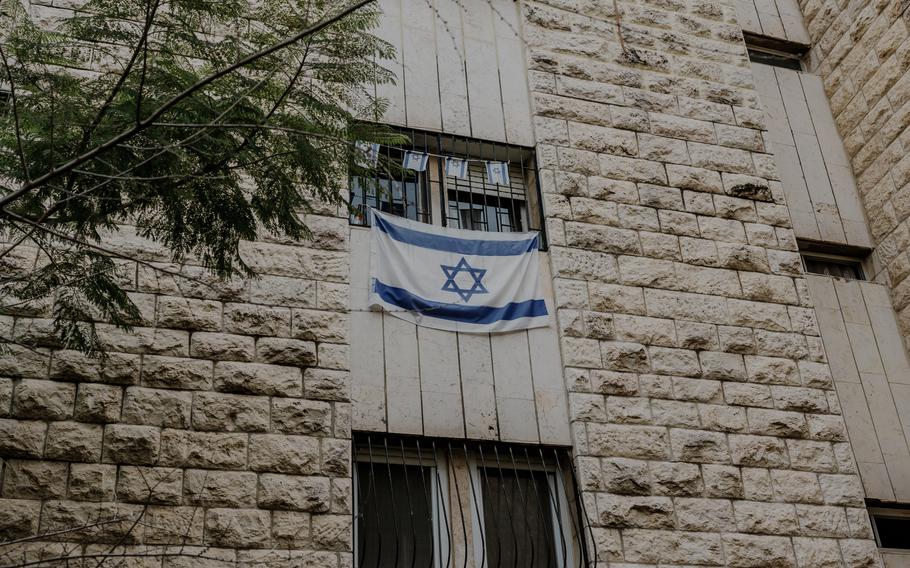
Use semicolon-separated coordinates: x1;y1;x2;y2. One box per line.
0;0;400;351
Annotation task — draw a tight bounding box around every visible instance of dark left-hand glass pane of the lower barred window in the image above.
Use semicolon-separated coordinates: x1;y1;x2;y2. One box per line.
357;462;434;567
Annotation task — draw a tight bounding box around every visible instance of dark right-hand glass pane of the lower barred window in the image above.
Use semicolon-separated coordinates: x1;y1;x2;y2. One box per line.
480;468;561;568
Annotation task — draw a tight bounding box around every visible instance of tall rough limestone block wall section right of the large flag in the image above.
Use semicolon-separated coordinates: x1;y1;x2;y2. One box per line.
524;0;879;567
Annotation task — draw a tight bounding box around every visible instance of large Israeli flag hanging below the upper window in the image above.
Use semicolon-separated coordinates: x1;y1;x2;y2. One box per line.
369;209;550;333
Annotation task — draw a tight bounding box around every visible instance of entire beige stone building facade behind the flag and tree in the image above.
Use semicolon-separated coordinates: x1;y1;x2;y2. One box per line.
0;0;910;568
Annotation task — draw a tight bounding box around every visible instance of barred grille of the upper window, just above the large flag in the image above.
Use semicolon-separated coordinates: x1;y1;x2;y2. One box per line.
350;126;544;242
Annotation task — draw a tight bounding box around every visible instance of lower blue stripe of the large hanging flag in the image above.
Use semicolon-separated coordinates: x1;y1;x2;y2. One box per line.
373;280;548;324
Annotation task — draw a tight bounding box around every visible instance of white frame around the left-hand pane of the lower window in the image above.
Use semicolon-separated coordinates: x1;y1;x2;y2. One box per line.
351;446;451;568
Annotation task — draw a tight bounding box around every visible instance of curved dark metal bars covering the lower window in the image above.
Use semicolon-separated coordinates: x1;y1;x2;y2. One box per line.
354;433;597;568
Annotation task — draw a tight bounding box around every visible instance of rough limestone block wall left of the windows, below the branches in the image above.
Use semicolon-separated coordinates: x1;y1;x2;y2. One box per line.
0;211;352;568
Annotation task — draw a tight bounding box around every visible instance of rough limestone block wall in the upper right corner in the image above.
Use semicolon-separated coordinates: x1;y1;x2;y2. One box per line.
800;0;910;342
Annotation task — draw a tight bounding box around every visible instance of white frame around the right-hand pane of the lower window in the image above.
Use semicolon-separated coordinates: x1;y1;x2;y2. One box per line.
468;455;584;568
